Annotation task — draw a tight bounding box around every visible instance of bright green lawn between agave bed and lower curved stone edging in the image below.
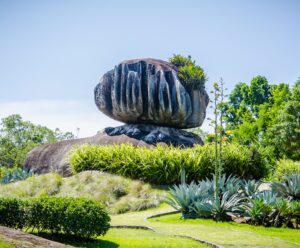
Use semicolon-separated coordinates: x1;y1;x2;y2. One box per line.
112;206;300;248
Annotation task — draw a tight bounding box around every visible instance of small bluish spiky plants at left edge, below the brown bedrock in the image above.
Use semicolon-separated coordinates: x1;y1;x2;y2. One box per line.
0;167;33;184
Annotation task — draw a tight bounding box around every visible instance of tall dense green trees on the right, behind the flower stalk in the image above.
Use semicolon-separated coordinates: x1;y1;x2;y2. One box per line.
223;76;300;160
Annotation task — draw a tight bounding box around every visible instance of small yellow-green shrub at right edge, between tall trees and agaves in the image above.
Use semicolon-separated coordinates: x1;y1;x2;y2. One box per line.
273;159;300;181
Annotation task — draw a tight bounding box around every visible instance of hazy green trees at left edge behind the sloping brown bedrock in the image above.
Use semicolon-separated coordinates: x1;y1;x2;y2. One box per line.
0;114;74;167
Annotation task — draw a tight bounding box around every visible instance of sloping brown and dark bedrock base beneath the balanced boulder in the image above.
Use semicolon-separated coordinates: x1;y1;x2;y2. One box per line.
24;124;203;176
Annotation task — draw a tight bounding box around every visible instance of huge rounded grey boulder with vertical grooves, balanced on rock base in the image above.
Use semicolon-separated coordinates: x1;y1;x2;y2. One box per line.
94;59;208;128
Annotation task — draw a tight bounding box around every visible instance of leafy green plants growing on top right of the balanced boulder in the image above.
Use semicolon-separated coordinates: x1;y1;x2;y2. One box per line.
169;54;206;90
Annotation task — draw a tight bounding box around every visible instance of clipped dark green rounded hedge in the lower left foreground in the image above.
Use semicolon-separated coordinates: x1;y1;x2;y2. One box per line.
0;197;110;237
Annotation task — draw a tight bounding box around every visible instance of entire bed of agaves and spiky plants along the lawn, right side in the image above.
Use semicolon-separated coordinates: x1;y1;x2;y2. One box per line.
167;174;300;228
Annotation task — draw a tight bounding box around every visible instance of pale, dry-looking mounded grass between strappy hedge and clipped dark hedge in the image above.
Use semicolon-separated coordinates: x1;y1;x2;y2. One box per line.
0;171;165;214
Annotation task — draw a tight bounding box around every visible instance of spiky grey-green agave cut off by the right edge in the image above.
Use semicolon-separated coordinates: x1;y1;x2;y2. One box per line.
272;173;300;201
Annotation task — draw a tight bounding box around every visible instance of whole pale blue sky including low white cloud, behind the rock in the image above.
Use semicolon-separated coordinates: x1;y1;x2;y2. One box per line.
0;0;300;136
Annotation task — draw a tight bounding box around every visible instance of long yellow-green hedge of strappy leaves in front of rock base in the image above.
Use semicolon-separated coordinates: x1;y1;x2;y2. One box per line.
70;144;268;184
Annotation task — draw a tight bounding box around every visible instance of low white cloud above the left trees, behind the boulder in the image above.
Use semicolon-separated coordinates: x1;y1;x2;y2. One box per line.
0;100;211;137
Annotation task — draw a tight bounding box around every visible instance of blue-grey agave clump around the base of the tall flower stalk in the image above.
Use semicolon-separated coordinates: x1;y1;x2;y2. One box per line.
166;175;243;221
